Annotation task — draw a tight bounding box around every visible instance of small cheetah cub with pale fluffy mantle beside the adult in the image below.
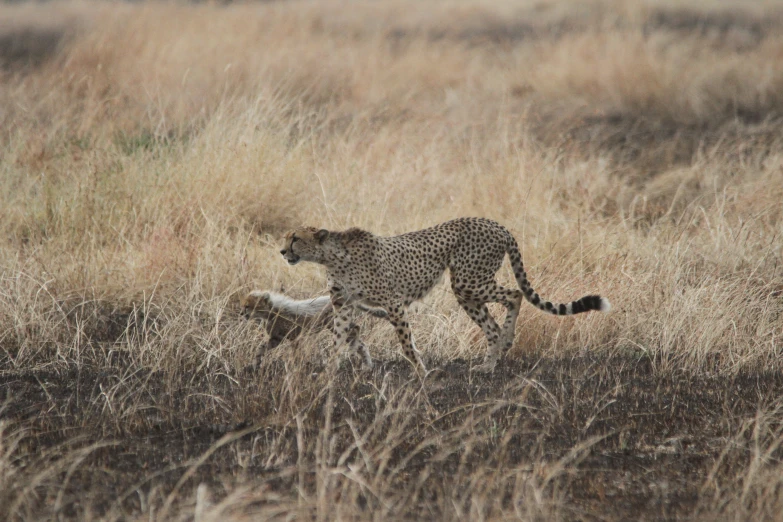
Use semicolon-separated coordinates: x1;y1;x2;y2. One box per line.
240;290;387;367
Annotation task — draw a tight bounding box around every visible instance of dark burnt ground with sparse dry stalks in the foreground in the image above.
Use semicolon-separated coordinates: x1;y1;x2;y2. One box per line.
0;346;783;520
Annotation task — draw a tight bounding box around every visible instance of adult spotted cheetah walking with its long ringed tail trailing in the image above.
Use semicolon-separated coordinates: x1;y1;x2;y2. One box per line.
280;218;611;372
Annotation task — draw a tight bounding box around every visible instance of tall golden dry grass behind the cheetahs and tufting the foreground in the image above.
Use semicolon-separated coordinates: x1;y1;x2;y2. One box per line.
0;0;783;520
